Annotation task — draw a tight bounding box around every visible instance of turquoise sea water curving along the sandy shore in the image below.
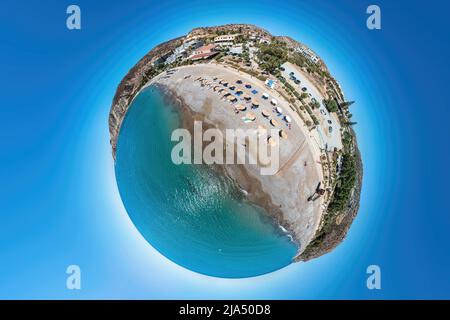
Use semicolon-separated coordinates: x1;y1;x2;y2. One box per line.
116;87;297;278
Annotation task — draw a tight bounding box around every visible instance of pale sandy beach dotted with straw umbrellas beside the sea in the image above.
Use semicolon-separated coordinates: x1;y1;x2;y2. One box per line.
146;64;324;254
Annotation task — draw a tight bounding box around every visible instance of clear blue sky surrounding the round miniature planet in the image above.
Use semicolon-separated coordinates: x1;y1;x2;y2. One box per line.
0;0;450;299
